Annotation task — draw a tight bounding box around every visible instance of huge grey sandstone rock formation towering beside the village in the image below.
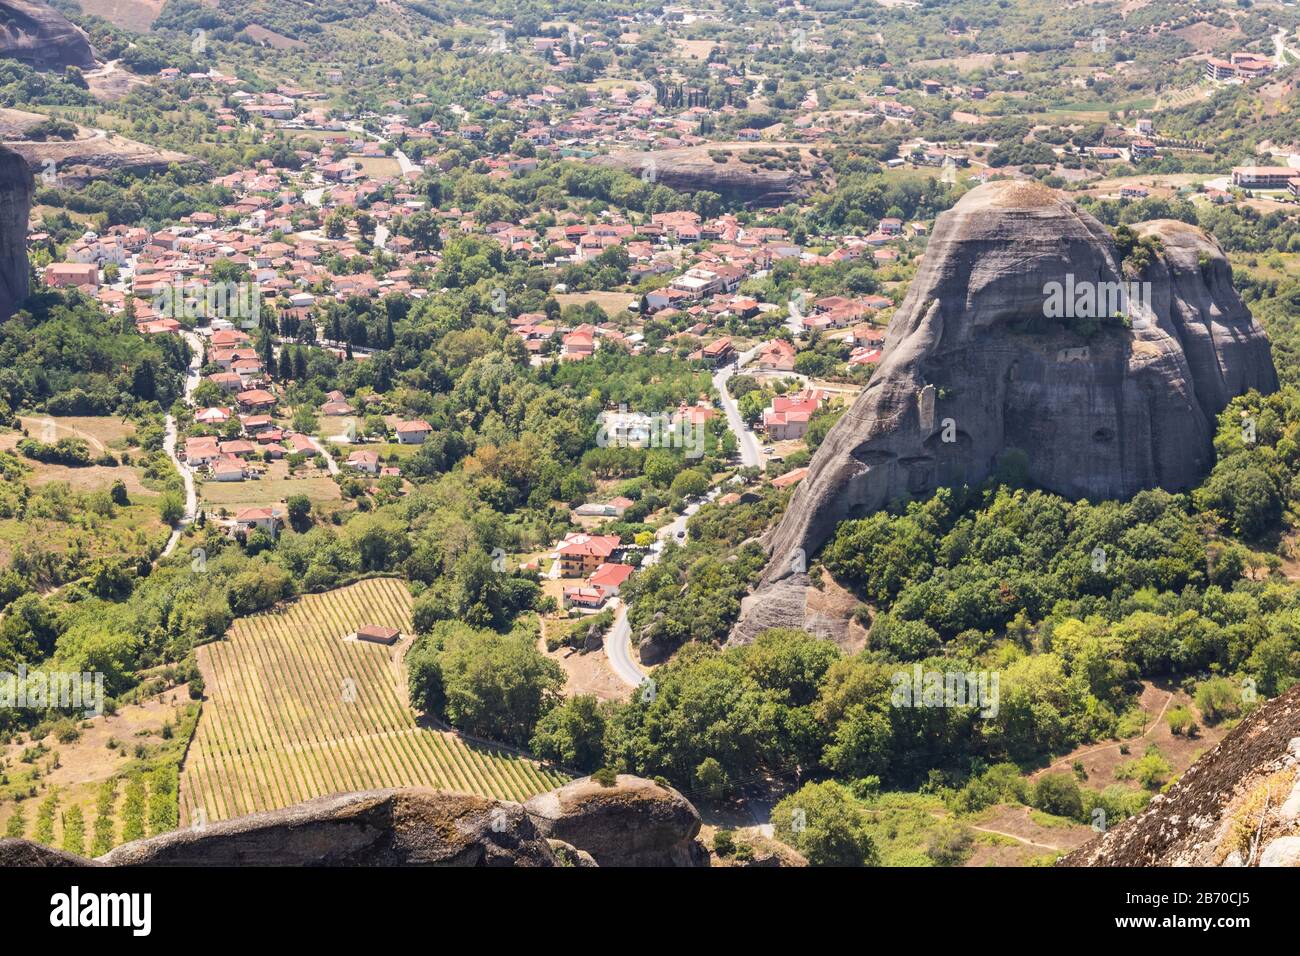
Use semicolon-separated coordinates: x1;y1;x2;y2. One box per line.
732;181;1278;643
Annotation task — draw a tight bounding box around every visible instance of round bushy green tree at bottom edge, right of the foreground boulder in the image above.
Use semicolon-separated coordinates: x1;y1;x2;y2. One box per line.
772;780;879;866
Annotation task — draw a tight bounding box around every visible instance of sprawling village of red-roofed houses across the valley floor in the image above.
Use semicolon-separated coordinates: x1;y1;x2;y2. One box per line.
20;11;1300;684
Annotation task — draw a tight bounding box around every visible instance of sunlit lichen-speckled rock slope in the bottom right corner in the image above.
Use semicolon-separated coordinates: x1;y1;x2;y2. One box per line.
1057;685;1300;866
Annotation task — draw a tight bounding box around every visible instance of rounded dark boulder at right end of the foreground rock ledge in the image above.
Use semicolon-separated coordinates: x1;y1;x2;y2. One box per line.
524;774;709;866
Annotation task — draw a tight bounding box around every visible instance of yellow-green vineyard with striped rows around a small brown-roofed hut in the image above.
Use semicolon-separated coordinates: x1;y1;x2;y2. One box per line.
181;578;566;826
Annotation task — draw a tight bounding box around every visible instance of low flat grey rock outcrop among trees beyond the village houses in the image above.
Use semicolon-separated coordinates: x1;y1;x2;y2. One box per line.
589;143;820;207
